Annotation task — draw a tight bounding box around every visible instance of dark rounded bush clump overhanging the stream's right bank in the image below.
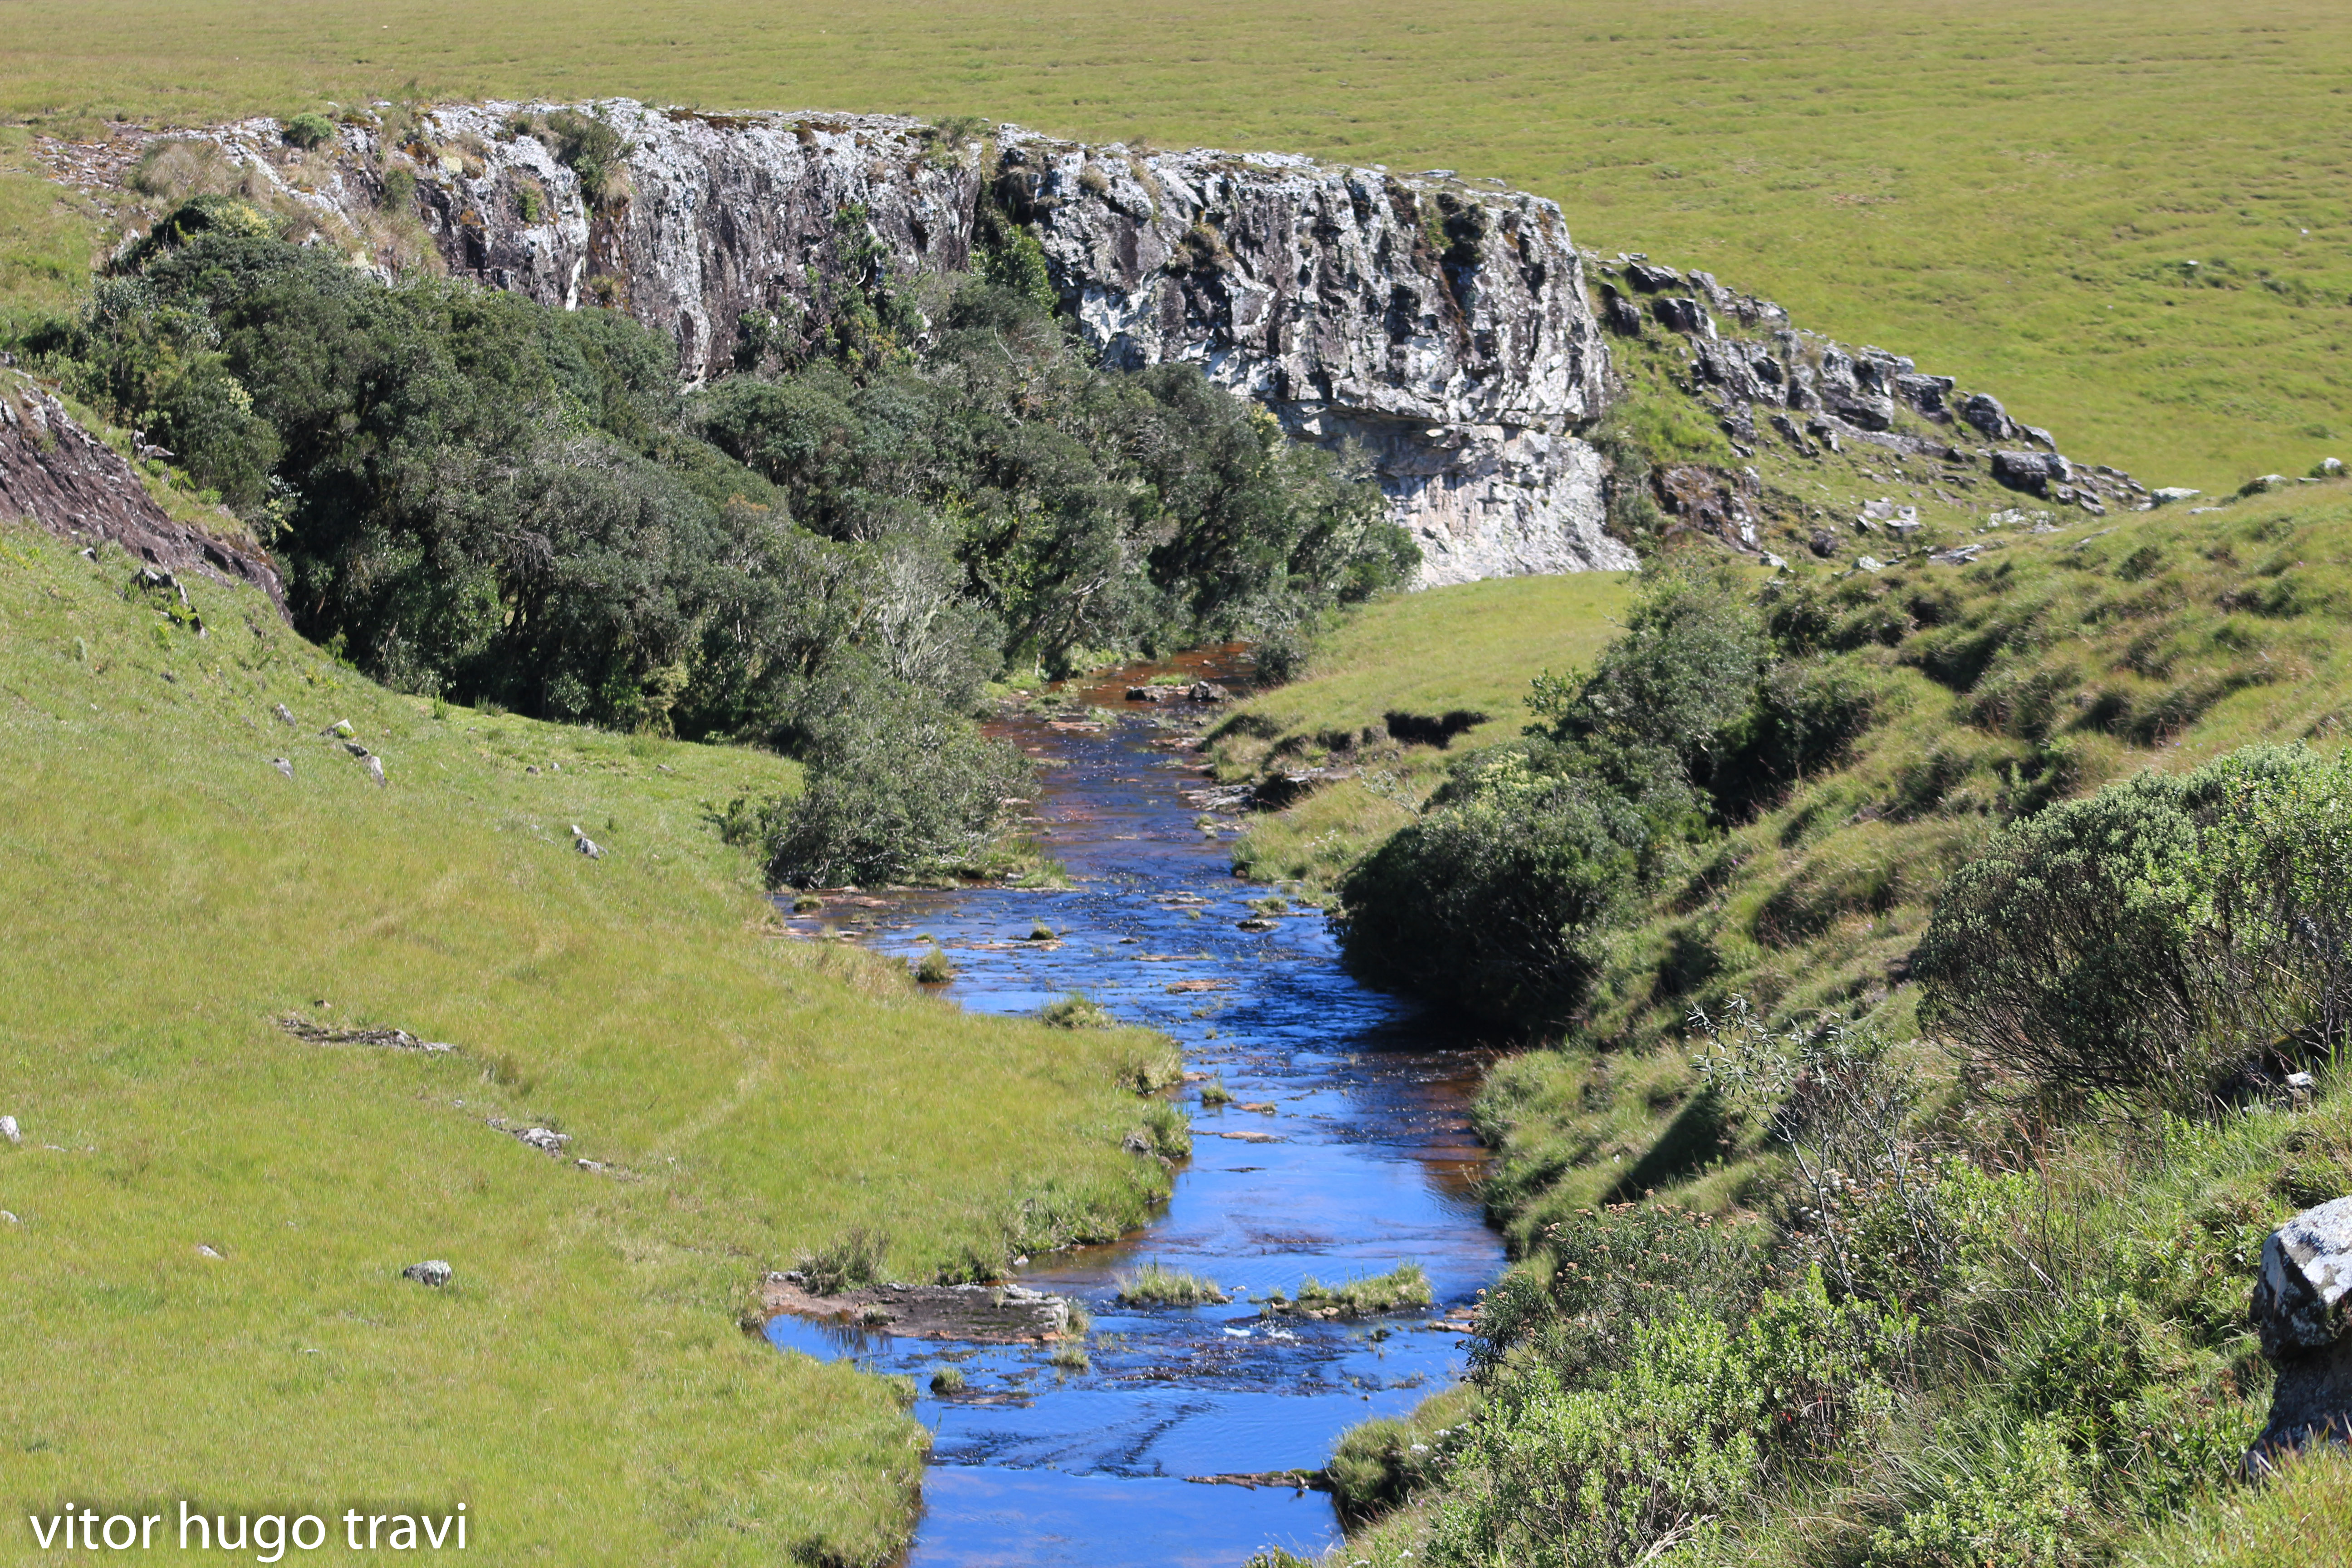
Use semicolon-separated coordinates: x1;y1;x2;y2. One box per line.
1336;571;1870;1027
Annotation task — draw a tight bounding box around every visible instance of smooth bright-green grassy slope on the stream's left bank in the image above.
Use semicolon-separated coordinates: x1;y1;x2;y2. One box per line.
0;527;1166;1563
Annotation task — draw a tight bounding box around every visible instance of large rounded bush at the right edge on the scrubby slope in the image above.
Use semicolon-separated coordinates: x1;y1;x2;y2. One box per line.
1919;748;2352;1110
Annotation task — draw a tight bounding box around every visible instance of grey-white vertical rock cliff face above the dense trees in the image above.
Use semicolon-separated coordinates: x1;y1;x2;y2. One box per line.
174;101;1635;583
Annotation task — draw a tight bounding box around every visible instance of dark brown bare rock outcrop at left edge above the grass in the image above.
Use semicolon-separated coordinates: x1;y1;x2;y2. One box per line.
0;372;287;616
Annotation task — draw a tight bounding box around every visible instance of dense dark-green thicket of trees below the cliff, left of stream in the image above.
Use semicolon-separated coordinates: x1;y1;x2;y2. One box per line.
24;197;1414;882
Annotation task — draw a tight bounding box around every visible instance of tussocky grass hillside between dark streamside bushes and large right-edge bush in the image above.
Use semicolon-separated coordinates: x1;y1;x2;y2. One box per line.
1484;482;2352;1241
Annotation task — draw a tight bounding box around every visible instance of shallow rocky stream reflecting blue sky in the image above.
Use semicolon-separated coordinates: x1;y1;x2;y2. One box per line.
767;661;1503;1568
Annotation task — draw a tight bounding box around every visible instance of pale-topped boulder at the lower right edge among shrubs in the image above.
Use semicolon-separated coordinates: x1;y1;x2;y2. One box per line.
2249;1196;2352;1467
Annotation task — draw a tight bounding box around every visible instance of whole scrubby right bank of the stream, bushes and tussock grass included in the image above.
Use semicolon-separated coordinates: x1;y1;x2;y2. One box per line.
1298;489;2352;1568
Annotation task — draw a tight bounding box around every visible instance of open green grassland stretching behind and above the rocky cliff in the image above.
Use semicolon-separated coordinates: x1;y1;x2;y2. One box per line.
0;0;2352;489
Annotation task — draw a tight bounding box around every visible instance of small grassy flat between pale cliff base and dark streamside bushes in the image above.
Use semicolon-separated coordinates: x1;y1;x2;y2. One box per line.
1209;571;1630;896
